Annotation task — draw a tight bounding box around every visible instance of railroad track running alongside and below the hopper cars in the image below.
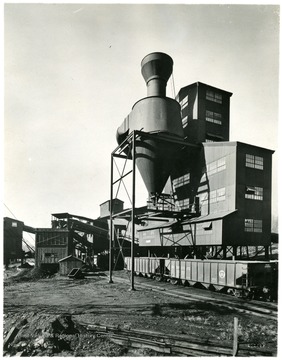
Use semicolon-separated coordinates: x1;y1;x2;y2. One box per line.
114;277;277;320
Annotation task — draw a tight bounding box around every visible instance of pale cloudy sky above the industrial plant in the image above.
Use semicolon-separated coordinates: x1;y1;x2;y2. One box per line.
3;2;279;236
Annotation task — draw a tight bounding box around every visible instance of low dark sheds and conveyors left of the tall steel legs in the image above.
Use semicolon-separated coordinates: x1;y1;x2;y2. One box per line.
4;199;123;274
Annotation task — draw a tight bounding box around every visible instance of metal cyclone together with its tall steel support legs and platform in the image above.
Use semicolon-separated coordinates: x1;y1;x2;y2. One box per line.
109;53;199;290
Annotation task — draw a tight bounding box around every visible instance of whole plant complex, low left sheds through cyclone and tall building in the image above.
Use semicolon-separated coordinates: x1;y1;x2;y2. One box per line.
4;53;273;276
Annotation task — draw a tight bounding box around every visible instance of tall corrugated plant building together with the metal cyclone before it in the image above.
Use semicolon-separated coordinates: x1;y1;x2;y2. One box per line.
112;53;273;259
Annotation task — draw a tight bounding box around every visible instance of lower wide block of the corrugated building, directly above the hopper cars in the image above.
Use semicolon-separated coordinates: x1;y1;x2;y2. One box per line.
139;142;273;256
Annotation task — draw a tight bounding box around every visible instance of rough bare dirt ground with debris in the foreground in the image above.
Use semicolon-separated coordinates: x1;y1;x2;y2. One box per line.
3;268;277;357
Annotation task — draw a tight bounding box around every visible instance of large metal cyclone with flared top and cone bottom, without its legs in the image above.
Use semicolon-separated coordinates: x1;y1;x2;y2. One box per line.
117;52;184;196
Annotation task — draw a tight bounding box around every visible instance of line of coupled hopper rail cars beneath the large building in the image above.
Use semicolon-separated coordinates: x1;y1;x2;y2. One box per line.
125;257;278;300
